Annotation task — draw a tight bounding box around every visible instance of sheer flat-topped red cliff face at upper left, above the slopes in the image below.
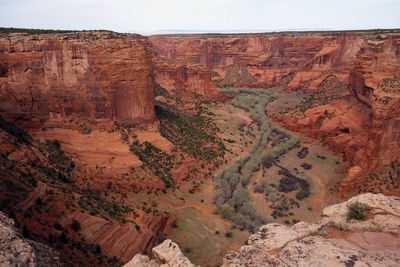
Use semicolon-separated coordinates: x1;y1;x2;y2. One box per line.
0;32;155;122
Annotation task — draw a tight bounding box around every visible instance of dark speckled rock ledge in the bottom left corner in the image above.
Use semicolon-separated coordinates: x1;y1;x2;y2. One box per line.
0;211;61;267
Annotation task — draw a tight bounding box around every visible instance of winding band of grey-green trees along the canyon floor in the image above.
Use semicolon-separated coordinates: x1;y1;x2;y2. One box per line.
214;89;299;232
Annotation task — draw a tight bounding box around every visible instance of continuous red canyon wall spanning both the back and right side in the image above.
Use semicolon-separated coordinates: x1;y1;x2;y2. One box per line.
149;32;400;195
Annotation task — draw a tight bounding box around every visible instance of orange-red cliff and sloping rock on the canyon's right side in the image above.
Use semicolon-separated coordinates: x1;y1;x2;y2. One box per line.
282;34;400;194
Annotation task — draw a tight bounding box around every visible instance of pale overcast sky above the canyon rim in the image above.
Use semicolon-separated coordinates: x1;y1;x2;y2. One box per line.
0;0;400;33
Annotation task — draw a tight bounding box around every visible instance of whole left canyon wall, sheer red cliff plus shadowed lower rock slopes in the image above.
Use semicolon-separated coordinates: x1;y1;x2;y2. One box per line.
0;32;171;265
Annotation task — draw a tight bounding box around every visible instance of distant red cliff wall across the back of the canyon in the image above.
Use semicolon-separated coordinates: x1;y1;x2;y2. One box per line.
149;33;370;91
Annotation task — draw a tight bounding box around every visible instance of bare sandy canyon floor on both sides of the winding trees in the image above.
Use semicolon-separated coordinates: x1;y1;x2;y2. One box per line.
127;88;346;266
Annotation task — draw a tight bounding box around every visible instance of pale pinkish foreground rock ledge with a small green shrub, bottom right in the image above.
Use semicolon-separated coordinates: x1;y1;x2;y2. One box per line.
223;193;400;266
